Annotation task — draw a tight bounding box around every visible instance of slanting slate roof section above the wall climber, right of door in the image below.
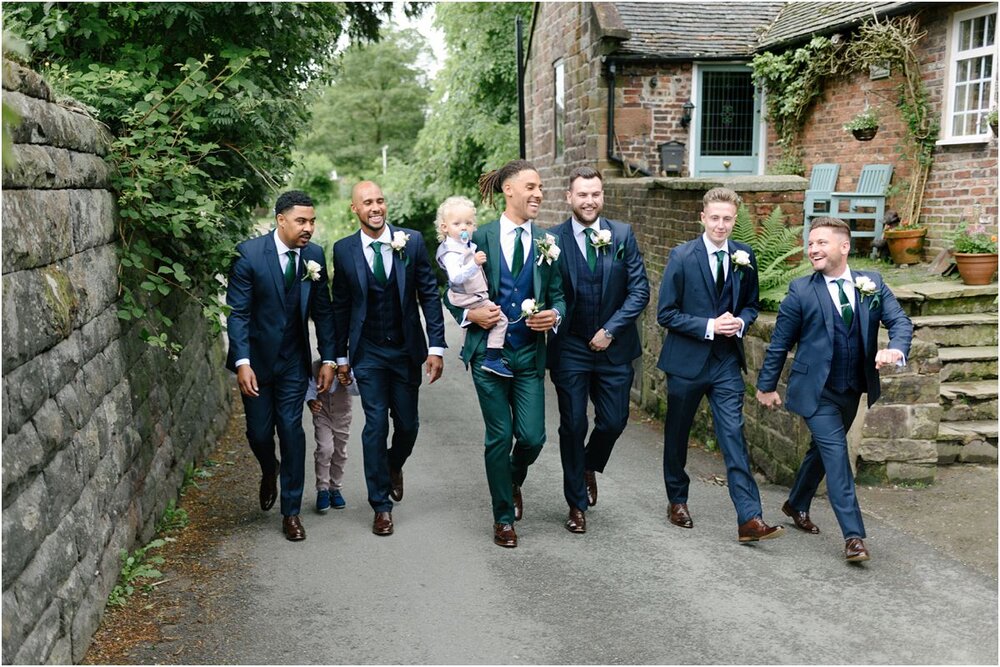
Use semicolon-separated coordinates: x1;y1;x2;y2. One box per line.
759;2;914;51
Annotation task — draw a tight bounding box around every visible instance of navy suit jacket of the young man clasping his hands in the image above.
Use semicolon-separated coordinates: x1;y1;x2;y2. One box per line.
656;236;759;378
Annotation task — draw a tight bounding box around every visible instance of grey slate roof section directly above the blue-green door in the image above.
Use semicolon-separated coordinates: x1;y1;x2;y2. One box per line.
614;2;786;60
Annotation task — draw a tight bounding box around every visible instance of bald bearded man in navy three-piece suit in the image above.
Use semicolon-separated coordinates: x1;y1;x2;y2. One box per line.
333;181;446;535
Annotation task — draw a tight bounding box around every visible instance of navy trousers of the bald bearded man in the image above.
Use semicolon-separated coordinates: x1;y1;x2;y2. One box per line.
353;340;421;512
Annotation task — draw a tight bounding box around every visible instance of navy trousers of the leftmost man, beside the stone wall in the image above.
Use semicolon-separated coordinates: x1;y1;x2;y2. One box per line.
243;356;309;516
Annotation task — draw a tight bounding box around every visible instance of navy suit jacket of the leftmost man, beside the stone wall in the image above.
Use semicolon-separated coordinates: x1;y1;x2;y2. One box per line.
226;229;335;382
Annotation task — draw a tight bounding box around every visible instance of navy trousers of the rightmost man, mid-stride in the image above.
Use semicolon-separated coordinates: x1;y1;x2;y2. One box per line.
788;389;866;540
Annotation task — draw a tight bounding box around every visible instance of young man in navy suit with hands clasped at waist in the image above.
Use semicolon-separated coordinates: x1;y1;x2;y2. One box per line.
656;188;784;542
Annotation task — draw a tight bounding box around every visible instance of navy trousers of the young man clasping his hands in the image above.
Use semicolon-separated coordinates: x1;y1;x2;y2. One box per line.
663;354;761;523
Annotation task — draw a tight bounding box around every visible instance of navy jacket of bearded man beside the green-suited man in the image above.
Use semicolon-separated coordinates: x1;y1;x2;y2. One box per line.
547;218;649;370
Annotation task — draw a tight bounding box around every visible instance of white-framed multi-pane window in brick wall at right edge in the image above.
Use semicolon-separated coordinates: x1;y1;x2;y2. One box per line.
941;4;997;140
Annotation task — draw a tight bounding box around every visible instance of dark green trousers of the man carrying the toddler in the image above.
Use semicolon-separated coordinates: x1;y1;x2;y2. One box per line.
472;344;545;524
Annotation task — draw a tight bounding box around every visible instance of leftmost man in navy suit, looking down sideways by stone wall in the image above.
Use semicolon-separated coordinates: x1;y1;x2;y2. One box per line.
226;191;334;541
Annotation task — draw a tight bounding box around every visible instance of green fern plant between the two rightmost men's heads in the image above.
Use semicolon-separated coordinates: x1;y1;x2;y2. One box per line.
731;204;809;307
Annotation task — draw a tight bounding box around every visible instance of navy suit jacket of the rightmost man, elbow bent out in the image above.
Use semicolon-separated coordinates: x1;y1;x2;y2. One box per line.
757;271;913;417
